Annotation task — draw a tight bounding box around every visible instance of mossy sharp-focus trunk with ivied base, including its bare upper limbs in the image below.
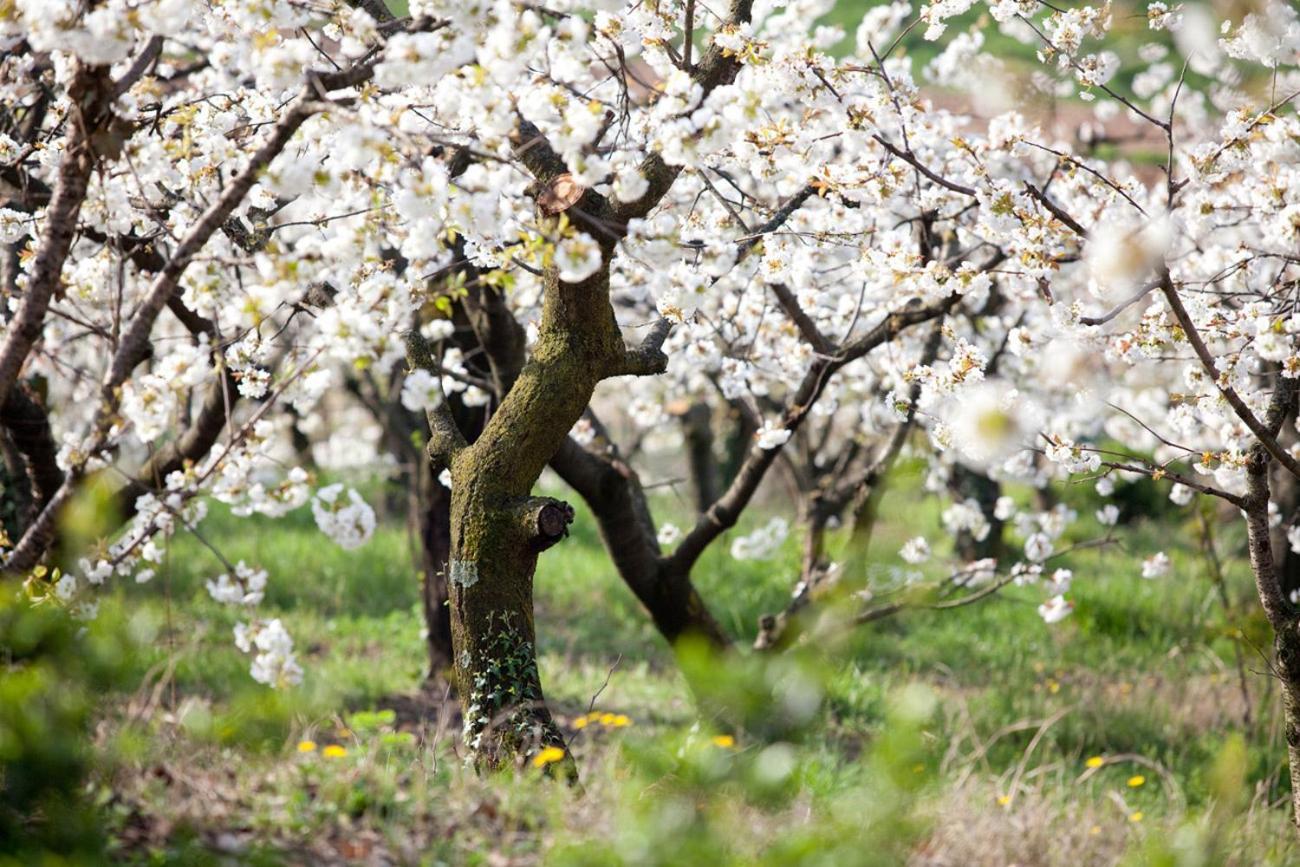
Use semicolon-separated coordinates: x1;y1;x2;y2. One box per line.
407;0;753;771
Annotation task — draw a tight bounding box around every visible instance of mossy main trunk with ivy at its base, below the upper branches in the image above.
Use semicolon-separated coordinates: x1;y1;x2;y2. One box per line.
408;252;639;773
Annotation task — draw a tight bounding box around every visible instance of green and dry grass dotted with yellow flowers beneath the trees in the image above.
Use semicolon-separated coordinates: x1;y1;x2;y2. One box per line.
55;457;1297;864
